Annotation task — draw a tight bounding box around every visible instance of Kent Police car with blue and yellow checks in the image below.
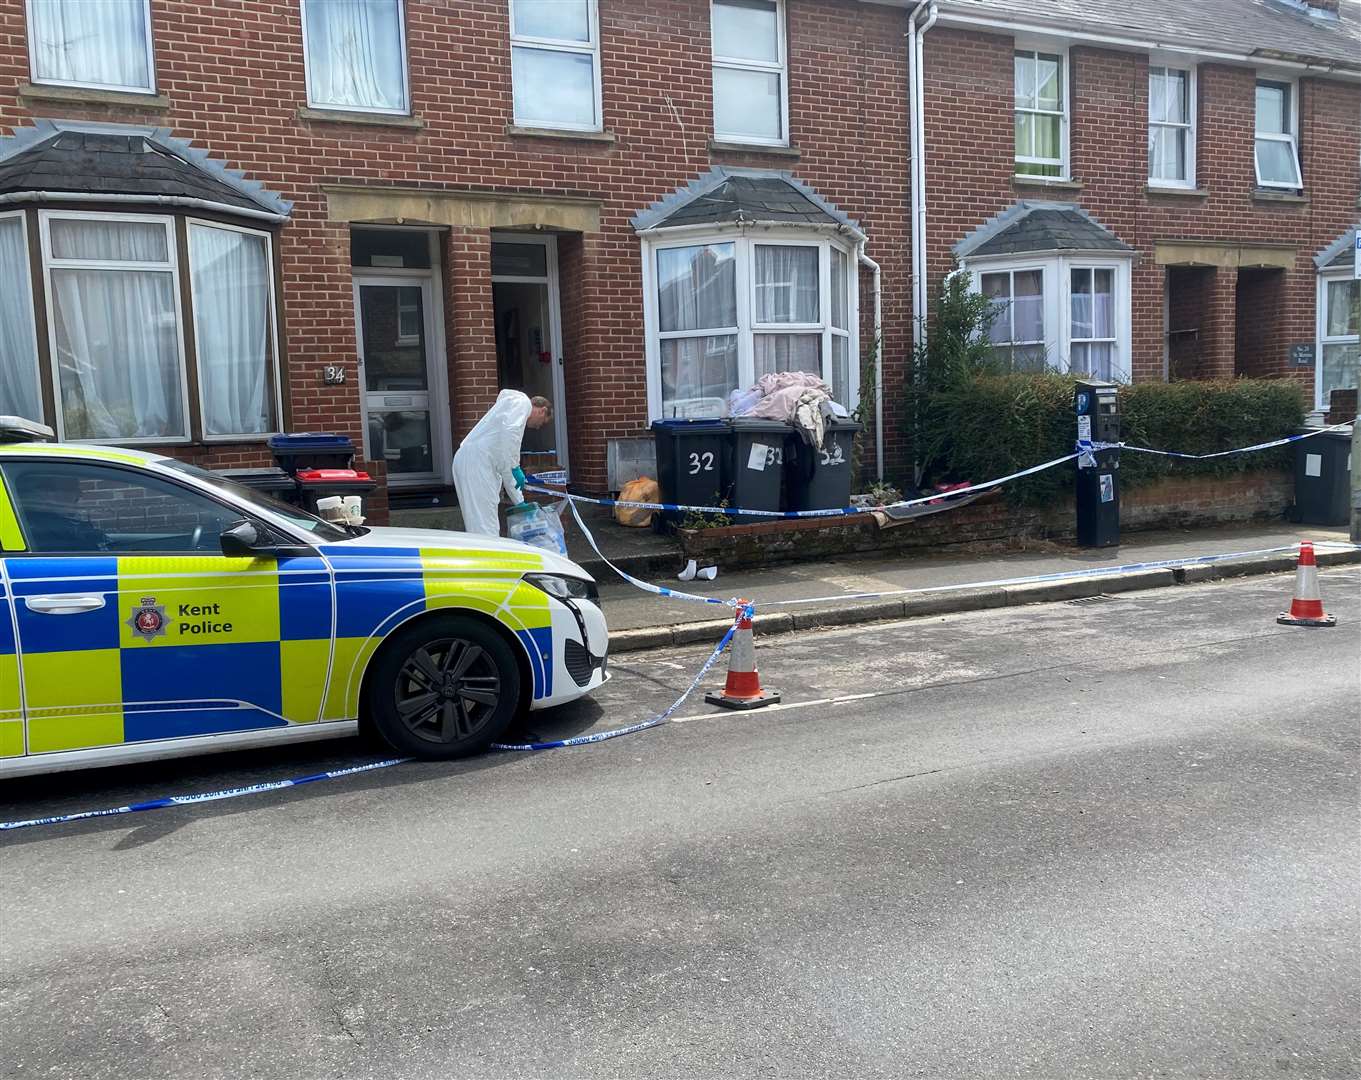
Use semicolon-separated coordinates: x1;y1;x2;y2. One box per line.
0;418;607;777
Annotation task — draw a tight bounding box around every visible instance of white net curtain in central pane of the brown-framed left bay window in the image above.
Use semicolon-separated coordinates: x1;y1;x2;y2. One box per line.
50;220;186;439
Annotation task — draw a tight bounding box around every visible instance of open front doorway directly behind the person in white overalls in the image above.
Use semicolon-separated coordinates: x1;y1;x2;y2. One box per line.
491;233;568;469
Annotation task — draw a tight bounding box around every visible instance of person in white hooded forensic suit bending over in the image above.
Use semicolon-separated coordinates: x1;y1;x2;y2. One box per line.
453;390;553;536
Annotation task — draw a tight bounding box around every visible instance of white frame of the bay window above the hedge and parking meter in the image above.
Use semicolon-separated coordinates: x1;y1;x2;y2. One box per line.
965;252;1132;382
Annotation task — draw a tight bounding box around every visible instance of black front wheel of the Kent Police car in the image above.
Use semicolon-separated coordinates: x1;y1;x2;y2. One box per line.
369;615;520;758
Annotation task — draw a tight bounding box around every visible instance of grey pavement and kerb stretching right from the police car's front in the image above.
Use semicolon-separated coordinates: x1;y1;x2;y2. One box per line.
595;521;1361;654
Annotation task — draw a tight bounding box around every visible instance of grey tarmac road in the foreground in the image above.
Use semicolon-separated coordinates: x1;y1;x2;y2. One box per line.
0;567;1361;1080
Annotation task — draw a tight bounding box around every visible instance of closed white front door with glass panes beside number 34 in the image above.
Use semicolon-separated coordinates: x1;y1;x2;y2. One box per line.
354;276;449;487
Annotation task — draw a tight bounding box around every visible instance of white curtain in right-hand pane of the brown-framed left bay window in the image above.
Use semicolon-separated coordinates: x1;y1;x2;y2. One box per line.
189;224;274;435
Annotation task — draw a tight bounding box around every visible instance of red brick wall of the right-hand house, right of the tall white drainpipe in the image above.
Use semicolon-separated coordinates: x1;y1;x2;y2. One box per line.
923;27;1361;388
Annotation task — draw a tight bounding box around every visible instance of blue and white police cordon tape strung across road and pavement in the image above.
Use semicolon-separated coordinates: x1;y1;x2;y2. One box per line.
0;424;1361;832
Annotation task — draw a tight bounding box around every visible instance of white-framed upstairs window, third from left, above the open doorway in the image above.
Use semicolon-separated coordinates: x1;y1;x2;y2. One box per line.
510;0;602;131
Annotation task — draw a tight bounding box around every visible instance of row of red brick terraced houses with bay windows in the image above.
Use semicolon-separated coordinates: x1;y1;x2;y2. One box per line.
0;0;1361;505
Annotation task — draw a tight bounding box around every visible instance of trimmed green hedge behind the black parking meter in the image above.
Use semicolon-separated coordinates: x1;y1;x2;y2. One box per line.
915;374;1305;503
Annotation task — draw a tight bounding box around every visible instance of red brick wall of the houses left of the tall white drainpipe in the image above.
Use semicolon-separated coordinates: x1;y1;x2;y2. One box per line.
0;0;911;487
